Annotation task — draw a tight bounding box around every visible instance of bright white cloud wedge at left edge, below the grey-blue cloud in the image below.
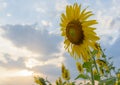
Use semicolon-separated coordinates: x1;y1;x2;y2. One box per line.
0;28;39;60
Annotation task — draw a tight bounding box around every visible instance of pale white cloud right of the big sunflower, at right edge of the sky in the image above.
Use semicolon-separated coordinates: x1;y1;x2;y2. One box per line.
96;2;120;46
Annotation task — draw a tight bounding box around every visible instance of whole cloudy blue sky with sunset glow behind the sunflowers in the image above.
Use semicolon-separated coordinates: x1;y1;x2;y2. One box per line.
0;0;120;85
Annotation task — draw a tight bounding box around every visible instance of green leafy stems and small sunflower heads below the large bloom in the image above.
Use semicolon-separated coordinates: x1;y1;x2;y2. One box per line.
35;46;120;85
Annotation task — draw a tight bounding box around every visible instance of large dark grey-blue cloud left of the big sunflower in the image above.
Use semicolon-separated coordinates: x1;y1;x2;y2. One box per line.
3;25;61;55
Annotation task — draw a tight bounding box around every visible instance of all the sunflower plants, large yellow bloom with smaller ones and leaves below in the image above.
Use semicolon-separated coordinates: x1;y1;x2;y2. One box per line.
34;3;120;85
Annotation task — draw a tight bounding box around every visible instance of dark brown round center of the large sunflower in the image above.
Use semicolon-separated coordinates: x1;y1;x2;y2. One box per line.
66;20;84;45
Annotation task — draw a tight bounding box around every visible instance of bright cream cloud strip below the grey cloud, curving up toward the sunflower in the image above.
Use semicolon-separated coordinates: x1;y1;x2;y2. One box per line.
25;43;65;68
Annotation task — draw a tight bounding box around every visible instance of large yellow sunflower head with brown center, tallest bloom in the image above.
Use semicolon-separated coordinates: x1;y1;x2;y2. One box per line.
60;3;99;61
